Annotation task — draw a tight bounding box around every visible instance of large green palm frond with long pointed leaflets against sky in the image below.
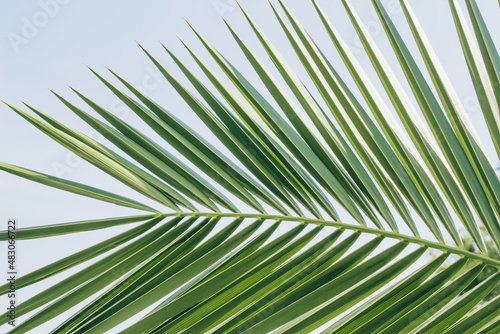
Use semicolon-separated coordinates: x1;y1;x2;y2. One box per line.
0;0;500;334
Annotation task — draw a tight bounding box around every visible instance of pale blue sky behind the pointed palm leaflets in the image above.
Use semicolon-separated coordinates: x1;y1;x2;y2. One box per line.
0;0;500;332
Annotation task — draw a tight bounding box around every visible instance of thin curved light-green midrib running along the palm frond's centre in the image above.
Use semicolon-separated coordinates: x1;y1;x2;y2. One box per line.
161;212;500;269
